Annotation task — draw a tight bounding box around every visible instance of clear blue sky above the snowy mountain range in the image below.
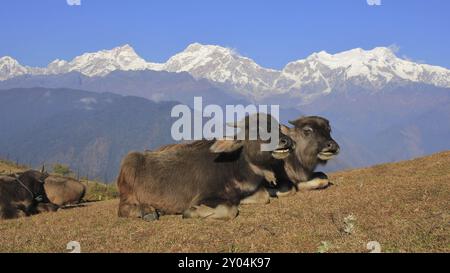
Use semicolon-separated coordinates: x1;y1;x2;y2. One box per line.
0;0;450;69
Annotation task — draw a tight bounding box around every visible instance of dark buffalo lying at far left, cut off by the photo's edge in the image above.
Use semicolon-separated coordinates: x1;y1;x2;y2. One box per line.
0;170;49;219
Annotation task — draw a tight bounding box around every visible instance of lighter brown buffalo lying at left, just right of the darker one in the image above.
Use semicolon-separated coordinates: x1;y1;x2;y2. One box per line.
44;175;86;206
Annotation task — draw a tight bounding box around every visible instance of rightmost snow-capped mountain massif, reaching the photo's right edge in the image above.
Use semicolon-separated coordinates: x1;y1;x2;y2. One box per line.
274;47;450;100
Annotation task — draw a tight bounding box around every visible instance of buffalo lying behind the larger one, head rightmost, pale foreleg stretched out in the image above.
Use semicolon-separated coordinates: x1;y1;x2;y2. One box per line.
268;116;340;196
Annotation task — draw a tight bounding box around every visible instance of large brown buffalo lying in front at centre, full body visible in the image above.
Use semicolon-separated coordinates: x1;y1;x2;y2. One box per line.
117;113;292;220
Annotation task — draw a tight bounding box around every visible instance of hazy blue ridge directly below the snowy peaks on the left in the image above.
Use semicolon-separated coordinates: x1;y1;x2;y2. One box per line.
0;70;248;105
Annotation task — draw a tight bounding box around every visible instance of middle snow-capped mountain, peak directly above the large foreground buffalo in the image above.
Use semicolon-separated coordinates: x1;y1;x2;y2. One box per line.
163;43;280;94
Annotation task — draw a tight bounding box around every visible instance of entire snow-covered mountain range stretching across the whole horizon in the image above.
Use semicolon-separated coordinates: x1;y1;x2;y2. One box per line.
0;43;450;101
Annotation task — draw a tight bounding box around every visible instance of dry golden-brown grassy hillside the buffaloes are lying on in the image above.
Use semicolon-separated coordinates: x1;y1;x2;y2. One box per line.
0;152;450;252
